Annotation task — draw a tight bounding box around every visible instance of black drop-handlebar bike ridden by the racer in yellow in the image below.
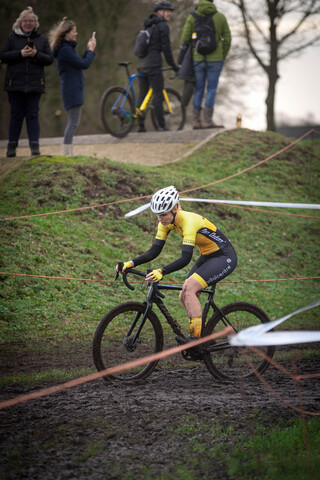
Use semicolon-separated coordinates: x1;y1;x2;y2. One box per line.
92;262;275;381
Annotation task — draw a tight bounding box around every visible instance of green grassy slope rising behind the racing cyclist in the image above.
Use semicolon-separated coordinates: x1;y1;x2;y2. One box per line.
0;129;320;381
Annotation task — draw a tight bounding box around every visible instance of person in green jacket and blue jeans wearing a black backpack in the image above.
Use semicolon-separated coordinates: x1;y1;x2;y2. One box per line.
182;0;231;129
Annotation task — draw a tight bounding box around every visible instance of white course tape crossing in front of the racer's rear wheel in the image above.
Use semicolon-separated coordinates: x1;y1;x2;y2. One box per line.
229;300;320;347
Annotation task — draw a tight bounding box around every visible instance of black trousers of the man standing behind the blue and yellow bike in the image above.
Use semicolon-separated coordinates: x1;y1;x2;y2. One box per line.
138;68;166;128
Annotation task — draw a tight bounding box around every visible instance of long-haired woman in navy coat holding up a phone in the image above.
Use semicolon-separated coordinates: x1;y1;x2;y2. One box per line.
49;17;96;157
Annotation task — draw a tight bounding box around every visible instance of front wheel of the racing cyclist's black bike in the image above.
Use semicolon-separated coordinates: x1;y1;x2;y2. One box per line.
92;302;163;380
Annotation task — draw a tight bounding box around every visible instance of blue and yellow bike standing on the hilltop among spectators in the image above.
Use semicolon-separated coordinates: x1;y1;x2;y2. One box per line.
100;62;186;138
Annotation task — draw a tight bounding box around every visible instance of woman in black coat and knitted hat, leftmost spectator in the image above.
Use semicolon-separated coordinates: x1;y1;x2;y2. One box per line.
0;7;53;157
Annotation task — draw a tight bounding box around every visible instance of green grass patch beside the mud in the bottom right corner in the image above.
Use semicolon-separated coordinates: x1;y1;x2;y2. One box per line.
158;412;320;480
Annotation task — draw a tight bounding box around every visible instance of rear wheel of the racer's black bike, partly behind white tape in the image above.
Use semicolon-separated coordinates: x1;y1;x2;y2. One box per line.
203;302;275;380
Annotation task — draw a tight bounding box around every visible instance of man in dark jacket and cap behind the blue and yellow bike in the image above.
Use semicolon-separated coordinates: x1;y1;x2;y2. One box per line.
137;1;179;132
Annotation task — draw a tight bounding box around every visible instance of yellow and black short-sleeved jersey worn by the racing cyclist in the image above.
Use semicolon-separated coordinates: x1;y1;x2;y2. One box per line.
156;209;230;255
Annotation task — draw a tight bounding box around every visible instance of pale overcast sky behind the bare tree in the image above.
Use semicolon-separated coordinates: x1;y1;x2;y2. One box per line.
215;1;320;130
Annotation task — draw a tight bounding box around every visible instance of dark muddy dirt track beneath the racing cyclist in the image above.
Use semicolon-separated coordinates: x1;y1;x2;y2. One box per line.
0;348;320;480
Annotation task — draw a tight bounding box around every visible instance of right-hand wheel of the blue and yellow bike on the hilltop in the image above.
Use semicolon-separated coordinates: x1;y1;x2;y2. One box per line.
151;87;186;130
